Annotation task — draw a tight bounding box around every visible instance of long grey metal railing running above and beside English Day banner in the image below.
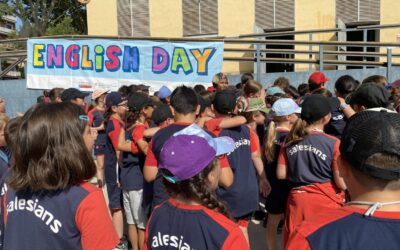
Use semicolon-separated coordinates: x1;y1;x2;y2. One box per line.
0;24;400;81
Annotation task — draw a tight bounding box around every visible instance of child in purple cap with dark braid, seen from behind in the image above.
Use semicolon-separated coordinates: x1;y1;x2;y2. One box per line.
145;125;249;250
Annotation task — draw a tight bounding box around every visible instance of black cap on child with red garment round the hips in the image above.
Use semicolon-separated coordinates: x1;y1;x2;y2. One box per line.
300;94;340;123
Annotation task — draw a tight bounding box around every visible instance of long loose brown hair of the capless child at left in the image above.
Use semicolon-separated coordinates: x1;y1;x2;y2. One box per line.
8;102;96;191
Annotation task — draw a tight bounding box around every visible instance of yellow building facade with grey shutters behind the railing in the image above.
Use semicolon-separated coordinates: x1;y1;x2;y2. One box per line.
87;0;400;73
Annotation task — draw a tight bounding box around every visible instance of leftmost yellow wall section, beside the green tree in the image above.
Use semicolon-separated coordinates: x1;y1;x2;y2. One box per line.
86;0;118;36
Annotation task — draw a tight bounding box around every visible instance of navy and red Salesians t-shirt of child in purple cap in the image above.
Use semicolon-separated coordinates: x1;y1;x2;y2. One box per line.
145;199;248;250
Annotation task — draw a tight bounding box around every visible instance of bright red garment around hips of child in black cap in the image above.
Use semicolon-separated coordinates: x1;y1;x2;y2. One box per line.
284;182;344;245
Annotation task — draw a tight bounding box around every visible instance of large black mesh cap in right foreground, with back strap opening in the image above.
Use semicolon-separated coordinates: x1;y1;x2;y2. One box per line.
340;110;400;180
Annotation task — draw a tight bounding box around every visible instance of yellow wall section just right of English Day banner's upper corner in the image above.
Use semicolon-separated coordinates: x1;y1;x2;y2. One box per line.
218;0;255;73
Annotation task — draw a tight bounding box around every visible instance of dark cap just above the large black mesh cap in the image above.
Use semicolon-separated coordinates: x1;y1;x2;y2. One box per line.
350;82;390;109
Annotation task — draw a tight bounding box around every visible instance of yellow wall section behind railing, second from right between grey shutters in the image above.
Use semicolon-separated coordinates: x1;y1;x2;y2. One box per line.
294;0;336;71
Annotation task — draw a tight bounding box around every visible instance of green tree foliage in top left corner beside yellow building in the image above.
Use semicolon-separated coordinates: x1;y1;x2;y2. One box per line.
0;0;87;37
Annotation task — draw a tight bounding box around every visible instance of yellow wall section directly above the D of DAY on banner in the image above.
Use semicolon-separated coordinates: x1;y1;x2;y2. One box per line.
149;0;183;37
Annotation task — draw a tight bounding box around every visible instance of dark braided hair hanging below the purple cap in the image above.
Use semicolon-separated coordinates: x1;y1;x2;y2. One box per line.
161;160;232;219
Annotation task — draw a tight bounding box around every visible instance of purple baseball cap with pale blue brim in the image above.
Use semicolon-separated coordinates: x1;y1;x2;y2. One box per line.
159;124;235;183
